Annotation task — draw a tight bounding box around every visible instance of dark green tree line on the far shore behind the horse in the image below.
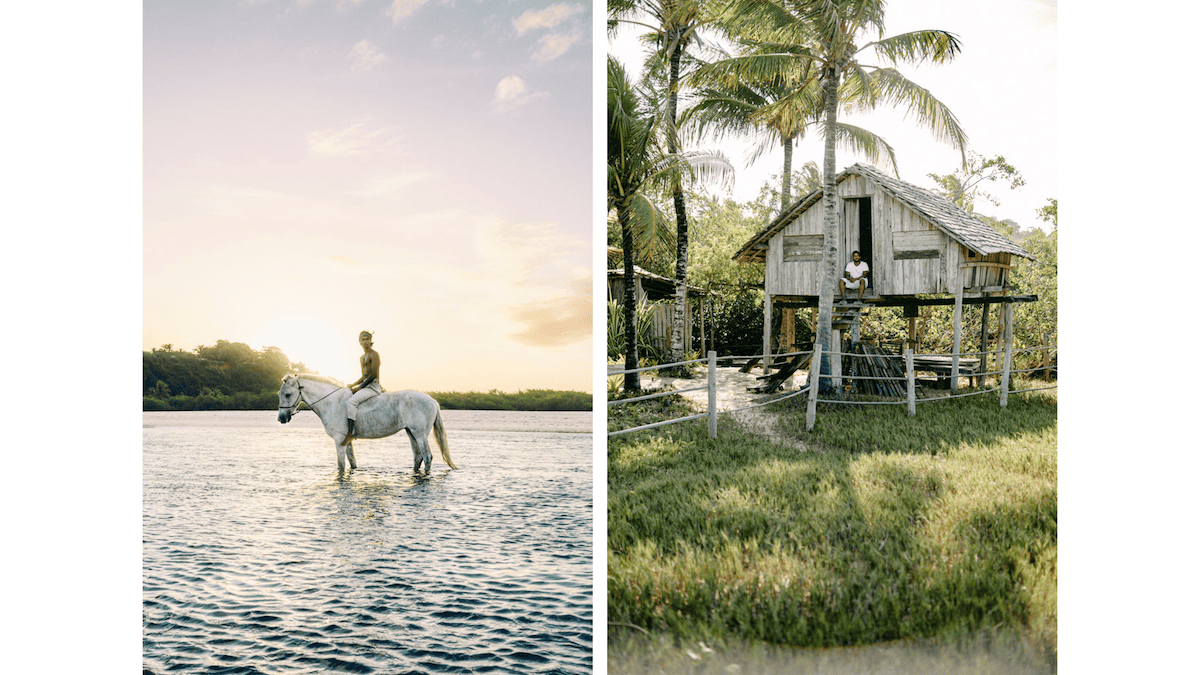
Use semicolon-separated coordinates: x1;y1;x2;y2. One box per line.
142;340;592;411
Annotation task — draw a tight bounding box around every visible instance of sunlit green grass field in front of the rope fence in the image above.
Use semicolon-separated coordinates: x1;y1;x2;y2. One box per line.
608;381;1057;669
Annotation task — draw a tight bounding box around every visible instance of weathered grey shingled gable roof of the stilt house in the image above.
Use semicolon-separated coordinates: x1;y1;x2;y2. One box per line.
733;165;1033;262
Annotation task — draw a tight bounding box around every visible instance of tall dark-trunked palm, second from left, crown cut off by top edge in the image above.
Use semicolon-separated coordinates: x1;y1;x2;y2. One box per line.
608;0;703;362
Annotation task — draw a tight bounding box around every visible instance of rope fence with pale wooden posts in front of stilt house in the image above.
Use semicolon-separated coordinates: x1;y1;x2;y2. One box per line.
607;333;1058;438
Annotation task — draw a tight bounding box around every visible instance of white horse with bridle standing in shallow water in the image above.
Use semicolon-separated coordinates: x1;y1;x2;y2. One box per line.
280;374;458;472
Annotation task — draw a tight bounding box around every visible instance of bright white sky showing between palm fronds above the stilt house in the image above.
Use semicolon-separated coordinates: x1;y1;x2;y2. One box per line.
608;0;1058;228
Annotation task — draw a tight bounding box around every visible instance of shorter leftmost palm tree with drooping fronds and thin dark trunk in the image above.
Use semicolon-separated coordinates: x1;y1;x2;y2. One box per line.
607;56;732;392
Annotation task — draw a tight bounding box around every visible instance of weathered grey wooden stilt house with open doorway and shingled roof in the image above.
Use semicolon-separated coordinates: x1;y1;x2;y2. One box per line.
733;165;1032;384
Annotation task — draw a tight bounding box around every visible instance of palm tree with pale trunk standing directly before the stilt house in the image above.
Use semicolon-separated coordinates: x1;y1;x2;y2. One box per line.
722;0;966;384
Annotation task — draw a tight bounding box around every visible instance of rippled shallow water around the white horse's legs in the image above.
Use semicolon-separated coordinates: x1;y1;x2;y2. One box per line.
143;411;593;674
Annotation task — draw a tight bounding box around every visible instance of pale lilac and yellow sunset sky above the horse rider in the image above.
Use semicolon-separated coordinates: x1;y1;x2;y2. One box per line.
142;0;593;392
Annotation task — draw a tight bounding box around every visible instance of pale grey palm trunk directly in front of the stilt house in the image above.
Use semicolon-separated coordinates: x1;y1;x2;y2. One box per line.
817;62;841;391
